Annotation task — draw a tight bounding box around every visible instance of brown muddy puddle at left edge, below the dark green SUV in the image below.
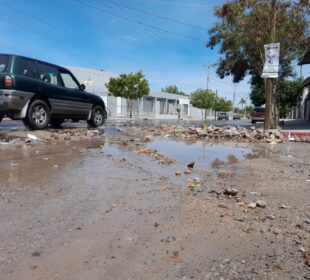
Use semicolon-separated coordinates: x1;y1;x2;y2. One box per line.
0;140;102;189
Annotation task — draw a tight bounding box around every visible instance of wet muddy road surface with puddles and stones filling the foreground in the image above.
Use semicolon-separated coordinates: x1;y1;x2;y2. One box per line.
0;126;310;280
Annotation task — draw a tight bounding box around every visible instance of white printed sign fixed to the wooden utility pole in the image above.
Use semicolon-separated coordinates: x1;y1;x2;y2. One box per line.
262;43;280;79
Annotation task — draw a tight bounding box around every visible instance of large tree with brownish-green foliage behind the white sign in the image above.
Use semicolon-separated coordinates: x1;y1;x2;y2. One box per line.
207;0;310;127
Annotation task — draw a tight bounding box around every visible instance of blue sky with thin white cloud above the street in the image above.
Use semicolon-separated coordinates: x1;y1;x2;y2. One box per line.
0;0;306;105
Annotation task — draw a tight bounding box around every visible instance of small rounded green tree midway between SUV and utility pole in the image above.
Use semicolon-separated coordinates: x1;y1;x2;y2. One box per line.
190;89;216;118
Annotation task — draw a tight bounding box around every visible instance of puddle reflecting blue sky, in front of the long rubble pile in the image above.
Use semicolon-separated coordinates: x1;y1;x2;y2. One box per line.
102;138;268;169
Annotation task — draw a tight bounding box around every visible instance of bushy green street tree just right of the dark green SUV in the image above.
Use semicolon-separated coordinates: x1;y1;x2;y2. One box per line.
105;71;150;117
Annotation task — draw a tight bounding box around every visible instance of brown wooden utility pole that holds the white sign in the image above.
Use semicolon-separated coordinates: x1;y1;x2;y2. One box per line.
264;0;277;130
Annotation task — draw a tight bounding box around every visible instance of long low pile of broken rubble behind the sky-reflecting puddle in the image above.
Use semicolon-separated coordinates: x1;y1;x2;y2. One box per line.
133;125;284;143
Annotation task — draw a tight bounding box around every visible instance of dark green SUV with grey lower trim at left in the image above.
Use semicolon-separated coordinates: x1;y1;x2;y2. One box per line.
0;54;107;129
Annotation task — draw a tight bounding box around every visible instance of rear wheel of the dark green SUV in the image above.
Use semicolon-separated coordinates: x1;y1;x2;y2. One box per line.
23;99;50;129
